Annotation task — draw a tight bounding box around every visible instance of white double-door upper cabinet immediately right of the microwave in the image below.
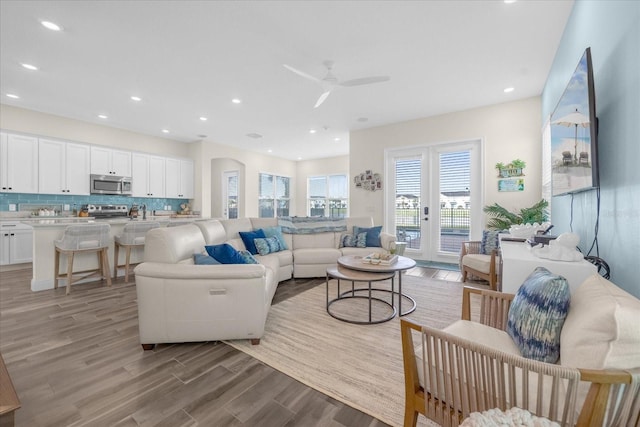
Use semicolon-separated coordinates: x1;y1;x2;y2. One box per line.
131;153;166;198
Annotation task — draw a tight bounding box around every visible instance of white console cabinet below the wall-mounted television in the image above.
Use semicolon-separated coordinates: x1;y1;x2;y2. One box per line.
500;240;597;294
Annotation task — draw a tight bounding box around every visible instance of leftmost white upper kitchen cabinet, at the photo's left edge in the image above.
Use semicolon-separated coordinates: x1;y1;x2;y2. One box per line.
0;132;38;193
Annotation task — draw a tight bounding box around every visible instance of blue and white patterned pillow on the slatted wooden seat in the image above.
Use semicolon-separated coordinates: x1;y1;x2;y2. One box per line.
507;267;571;363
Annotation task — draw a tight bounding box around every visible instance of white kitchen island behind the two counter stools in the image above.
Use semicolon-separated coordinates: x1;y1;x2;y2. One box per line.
24;216;206;291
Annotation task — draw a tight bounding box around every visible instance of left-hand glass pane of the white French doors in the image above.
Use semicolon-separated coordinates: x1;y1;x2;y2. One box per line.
395;159;422;249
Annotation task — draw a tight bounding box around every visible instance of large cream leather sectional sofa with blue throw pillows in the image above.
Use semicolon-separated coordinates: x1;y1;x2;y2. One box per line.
135;217;395;350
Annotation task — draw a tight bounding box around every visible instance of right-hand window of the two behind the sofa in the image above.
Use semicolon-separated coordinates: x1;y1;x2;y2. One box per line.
307;175;349;218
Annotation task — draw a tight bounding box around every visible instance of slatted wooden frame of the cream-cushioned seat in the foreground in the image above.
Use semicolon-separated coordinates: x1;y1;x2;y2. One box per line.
400;287;640;427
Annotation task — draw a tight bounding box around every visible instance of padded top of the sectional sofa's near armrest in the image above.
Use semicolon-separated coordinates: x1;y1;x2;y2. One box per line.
134;262;266;279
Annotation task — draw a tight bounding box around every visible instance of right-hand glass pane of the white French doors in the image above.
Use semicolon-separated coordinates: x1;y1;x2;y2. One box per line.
439;151;471;253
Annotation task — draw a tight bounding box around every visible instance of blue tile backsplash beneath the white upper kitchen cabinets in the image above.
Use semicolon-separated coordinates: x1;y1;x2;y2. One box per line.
0;193;189;216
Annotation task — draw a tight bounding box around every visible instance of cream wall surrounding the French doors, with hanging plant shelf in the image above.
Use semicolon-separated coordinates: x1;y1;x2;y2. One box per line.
349;97;542;224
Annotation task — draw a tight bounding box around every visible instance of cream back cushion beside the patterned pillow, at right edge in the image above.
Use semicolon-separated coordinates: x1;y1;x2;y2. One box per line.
560;274;640;369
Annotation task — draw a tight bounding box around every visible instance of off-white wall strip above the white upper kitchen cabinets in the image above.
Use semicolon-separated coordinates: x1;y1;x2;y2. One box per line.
0;104;191;158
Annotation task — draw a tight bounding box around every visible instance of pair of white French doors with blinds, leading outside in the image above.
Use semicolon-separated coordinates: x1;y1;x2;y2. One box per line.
385;140;483;263
